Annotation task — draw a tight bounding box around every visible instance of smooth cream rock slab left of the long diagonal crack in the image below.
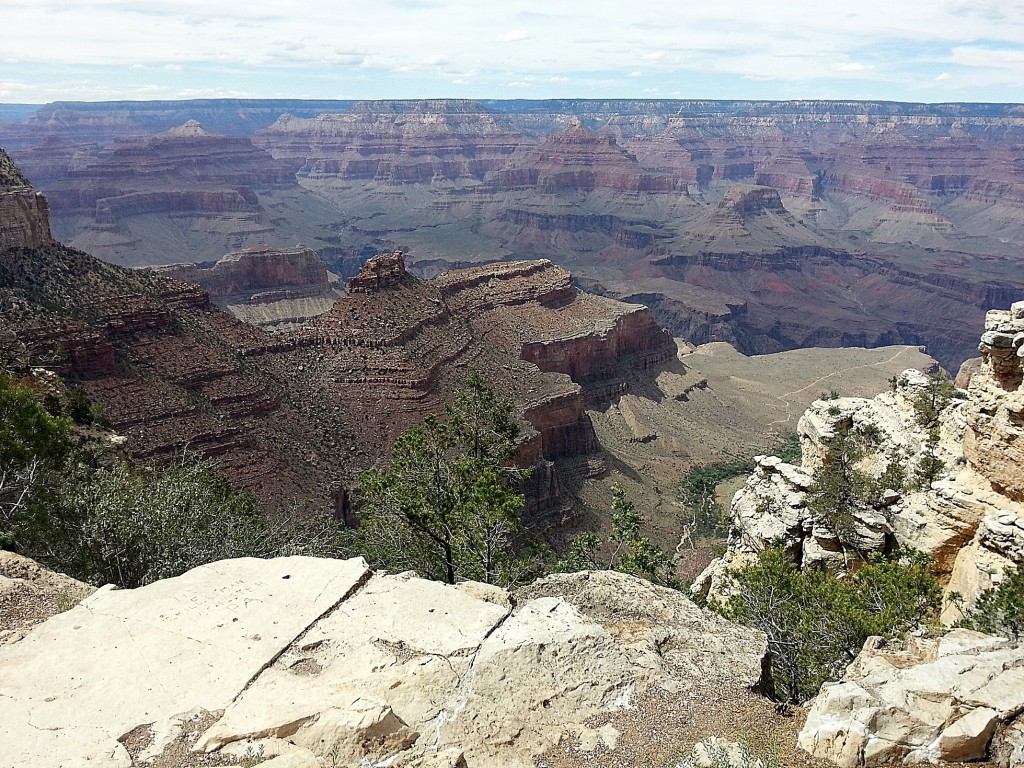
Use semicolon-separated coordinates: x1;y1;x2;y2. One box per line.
0;558;368;768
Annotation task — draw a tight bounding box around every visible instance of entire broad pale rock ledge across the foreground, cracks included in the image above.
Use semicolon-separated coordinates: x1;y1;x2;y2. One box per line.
0;557;766;768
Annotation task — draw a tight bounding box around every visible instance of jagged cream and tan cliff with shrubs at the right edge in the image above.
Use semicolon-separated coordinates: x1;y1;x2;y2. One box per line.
699;302;1024;623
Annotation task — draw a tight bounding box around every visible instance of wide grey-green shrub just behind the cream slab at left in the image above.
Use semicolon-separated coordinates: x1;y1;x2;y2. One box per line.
18;454;335;588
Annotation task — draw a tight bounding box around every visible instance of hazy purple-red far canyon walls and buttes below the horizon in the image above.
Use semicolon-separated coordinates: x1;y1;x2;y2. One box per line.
0;99;1024;370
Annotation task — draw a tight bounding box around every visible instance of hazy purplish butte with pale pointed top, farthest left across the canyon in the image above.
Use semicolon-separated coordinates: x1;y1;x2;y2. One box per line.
32;120;335;265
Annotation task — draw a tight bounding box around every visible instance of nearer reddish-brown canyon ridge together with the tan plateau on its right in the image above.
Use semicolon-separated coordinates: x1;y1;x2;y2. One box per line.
0;150;933;541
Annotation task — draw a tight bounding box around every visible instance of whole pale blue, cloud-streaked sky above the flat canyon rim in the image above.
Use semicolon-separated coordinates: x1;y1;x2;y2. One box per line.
0;0;1024;103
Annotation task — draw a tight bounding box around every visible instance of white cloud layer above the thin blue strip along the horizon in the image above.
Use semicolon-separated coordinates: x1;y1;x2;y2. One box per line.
6;0;1024;100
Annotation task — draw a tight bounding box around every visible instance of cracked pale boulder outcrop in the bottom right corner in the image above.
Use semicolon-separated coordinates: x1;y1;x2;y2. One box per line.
799;630;1024;768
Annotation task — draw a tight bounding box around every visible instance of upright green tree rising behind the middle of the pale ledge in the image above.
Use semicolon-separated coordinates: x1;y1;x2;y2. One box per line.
360;371;532;585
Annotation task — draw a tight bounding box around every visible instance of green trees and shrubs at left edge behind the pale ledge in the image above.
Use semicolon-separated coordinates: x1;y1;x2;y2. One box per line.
0;375;338;587
